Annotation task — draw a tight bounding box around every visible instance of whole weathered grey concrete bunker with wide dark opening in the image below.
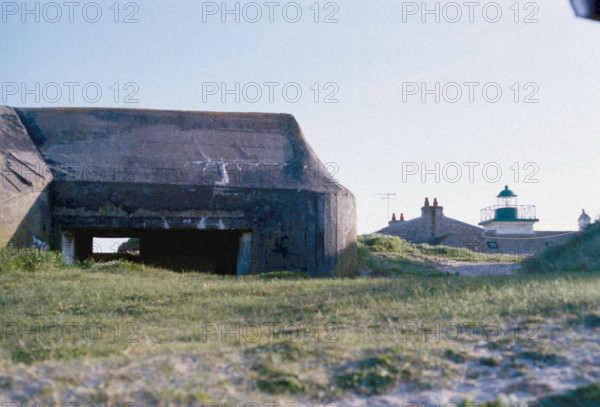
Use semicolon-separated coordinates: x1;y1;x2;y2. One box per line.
0;107;356;276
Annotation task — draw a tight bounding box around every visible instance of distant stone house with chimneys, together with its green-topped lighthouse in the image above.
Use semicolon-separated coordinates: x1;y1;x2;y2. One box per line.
377;186;591;256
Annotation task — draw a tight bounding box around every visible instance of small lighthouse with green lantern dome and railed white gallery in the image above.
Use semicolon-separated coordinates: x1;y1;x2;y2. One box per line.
479;185;539;235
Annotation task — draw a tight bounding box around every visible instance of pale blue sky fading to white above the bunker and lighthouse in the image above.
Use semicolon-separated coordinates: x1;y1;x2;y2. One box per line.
0;0;600;245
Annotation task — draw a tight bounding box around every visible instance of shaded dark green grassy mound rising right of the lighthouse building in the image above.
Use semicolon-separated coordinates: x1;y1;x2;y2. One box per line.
523;222;600;272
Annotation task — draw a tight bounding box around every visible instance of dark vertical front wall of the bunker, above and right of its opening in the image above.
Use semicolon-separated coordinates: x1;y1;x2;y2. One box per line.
52;181;356;276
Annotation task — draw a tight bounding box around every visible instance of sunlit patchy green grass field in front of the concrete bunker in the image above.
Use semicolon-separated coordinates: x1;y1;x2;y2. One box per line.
0;225;600;406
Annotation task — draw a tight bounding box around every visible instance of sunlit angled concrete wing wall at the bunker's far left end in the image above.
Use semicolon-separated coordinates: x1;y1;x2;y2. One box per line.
0;106;52;247
